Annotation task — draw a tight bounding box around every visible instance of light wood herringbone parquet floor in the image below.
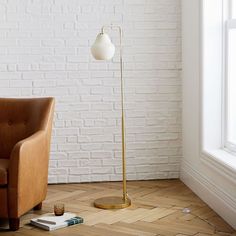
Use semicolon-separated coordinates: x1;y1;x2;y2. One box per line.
0;180;236;236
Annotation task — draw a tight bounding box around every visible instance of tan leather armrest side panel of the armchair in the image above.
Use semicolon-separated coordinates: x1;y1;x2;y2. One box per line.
8;130;49;217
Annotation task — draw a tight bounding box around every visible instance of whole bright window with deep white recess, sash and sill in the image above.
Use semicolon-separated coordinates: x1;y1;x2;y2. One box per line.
199;0;236;172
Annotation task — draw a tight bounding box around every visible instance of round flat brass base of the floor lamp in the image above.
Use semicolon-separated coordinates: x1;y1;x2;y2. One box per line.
94;197;131;209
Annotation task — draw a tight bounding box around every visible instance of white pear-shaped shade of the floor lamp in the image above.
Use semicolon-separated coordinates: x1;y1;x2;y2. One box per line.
91;33;115;60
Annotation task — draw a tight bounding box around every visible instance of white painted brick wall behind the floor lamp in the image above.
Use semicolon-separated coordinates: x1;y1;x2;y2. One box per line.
0;0;181;183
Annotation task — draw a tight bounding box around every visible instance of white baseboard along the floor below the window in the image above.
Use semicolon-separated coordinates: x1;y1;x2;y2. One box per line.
180;162;236;229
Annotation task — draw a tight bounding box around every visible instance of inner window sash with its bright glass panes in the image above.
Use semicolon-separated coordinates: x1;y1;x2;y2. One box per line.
224;0;236;152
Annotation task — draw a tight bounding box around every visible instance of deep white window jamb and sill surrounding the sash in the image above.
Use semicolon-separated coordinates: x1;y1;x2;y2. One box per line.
199;0;236;175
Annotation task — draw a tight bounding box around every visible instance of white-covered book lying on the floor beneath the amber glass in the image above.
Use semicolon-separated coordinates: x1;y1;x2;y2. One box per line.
30;212;84;231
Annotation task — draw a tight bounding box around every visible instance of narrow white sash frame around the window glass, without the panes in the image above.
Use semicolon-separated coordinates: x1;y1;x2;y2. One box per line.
222;0;236;155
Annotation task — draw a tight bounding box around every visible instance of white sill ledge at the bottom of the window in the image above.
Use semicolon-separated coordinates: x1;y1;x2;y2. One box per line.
201;149;236;183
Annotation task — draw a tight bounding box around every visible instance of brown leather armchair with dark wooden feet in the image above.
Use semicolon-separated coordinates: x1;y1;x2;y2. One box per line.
0;98;54;230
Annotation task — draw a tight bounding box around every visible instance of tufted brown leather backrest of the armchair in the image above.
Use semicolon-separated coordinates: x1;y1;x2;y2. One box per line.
0;98;53;159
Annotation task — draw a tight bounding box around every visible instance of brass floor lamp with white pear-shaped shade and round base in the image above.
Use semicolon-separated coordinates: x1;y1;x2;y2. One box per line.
91;25;131;209
